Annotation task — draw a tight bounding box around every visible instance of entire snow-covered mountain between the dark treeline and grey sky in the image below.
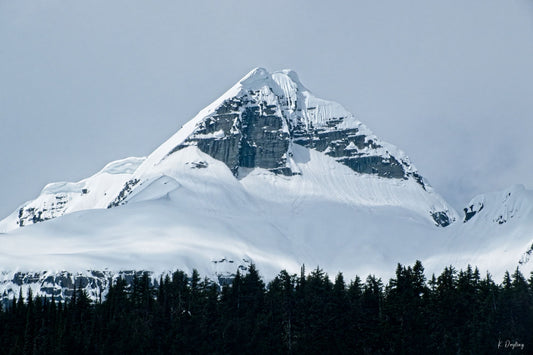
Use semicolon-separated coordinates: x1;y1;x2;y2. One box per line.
0;68;533;304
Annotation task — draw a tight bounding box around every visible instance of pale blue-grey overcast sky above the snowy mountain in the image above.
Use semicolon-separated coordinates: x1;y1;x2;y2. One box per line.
0;0;533;218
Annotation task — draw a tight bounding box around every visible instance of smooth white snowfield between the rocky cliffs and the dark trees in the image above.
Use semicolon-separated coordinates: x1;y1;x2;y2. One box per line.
0;143;533;286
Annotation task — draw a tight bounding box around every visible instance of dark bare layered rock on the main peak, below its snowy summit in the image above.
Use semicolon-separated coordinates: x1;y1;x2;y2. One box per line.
163;85;426;189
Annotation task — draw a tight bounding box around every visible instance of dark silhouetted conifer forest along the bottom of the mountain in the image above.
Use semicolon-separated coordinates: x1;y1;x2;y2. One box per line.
0;261;533;354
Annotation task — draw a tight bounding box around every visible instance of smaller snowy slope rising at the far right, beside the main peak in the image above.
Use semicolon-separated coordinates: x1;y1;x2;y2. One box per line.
424;185;533;276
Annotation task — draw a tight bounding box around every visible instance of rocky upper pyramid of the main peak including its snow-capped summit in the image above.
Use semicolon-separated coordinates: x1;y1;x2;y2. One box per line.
164;69;425;188
